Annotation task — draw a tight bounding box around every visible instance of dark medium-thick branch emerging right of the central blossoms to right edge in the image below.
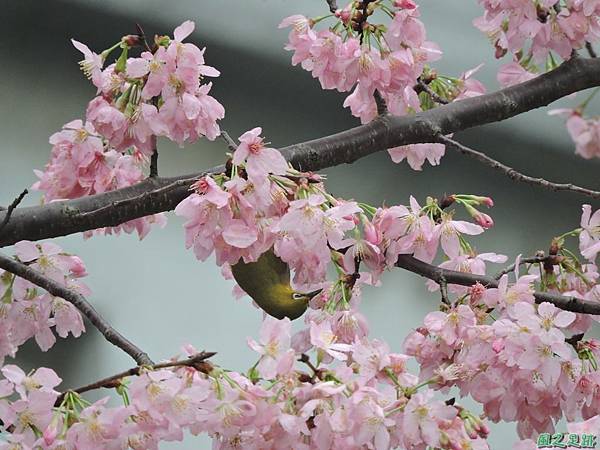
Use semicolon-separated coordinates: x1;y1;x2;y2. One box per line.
396;255;600;315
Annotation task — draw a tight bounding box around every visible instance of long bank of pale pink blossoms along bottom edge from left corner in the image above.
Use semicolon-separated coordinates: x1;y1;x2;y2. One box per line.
0;317;489;450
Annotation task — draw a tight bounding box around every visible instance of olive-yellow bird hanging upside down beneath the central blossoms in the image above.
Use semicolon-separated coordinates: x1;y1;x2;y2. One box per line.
231;248;321;320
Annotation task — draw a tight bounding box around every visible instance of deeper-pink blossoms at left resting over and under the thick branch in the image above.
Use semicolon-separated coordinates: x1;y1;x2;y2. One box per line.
33;120;167;239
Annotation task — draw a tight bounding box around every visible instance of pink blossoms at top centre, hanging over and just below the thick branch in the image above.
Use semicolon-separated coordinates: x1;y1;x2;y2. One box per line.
280;0;485;170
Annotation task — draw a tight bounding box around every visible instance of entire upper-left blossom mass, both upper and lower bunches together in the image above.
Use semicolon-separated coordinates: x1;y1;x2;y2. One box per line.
33;21;224;238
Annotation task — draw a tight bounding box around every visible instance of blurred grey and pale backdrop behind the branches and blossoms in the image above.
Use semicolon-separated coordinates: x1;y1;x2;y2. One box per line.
0;0;600;449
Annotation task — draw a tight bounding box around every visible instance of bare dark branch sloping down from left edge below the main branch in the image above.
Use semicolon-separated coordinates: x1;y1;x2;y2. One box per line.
0;253;153;365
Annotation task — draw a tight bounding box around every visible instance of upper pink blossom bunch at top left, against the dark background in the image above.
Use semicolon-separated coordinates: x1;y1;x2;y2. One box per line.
73;20;225;149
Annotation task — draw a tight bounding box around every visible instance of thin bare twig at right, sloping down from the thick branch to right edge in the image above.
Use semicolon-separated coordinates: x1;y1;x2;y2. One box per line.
436;134;600;199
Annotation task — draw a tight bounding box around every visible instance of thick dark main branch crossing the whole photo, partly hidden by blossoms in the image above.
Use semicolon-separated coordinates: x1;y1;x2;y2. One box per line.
0;58;600;246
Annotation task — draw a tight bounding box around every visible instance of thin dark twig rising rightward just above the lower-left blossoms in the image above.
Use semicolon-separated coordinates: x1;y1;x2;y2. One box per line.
56;352;216;405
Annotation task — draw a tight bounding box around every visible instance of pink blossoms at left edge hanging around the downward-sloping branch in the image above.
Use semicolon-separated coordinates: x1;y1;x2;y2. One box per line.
0;241;89;363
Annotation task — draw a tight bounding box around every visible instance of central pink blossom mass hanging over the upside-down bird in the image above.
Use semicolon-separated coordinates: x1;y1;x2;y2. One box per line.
175;128;493;287
